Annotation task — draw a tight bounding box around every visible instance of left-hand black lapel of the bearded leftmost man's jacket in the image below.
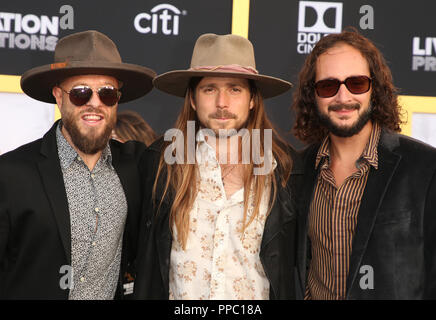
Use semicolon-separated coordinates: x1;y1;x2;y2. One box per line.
37;121;71;265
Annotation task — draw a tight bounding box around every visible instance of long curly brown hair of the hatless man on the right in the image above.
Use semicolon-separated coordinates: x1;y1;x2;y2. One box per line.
292;28;408;143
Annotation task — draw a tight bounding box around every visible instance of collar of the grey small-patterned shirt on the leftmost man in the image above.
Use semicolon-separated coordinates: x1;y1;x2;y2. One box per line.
56;121;112;169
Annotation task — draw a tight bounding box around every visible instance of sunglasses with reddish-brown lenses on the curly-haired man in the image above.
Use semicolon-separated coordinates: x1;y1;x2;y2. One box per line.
315;76;371;98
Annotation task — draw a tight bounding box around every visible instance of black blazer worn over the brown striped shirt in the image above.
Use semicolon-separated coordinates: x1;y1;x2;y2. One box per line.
298;130;436;299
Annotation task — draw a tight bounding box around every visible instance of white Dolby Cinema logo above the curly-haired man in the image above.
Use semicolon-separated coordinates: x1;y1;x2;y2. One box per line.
297;1;343;54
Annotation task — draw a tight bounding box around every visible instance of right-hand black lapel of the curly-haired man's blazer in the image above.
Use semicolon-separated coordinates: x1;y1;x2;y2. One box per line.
347;131;401;298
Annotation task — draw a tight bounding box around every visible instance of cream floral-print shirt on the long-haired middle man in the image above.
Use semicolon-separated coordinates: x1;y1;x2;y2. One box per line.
169;131;276;300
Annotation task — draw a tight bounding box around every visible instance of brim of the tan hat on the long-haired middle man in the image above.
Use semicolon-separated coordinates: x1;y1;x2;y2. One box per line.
153;70;293;99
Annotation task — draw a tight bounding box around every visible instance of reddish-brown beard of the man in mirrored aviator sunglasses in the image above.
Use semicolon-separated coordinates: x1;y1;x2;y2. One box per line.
62;108;116;154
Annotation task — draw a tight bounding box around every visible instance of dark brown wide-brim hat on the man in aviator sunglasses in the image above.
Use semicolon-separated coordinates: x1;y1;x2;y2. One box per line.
21;30;156;103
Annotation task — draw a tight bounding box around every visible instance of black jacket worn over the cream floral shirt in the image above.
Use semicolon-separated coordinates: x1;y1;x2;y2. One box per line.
134;140;302;299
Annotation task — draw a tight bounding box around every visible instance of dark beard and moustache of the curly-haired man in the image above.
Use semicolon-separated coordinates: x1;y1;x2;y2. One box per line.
317;103;372;138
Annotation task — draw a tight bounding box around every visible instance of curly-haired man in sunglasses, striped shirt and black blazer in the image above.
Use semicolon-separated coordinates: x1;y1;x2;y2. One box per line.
293;30;436;299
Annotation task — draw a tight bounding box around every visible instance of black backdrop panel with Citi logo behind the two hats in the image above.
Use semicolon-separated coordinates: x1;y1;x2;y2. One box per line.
0;0;233;149
